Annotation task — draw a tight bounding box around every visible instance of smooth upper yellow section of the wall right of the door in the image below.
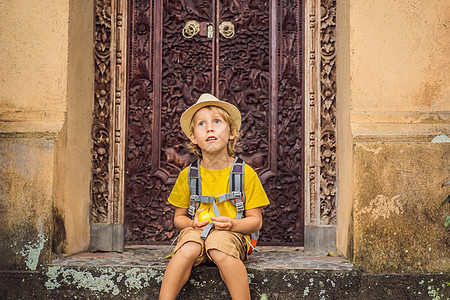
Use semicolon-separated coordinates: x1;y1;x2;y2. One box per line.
349;0;450;112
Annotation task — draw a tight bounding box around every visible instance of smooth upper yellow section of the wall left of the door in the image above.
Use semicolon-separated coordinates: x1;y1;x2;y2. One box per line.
0;0;69;111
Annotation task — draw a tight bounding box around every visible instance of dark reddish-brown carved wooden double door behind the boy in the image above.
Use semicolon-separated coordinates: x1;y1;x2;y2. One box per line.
125;0;304;245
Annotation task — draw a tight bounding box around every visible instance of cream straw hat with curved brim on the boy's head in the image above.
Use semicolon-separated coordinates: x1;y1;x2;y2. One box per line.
180;94;241;137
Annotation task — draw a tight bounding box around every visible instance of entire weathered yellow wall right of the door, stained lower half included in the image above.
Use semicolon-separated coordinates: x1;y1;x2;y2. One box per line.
337;0;450;271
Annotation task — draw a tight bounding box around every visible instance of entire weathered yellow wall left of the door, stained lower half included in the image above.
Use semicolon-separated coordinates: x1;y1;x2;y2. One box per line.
0;0;93;269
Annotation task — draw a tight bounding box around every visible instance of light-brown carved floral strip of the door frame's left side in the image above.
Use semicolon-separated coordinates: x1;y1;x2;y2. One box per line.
90;0;111;223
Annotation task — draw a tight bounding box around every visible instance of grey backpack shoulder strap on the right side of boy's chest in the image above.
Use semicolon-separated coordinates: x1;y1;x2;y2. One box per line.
229;157;245;219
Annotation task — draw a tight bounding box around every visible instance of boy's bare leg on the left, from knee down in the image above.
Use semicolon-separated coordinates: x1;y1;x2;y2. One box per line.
159;242;202;299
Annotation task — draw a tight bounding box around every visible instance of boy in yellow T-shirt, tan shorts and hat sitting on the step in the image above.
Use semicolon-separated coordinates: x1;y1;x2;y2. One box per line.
159;94;269;299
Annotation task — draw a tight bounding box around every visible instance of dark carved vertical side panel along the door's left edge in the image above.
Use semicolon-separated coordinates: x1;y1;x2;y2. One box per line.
125;0;153;241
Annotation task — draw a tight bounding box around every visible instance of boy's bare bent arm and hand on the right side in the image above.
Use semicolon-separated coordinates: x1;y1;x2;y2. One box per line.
211;207;262;234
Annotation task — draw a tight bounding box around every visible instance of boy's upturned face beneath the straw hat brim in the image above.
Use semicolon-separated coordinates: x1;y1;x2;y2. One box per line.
189;107;234;155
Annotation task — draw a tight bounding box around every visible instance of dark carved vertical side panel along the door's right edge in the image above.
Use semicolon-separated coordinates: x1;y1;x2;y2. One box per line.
266;0;304;245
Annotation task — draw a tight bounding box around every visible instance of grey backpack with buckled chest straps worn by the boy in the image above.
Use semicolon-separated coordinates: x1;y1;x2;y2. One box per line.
188;157;259;254
